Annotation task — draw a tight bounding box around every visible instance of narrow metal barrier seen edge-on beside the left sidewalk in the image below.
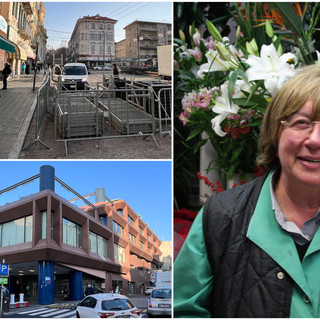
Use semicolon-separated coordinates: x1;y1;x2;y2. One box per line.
22;74;50;151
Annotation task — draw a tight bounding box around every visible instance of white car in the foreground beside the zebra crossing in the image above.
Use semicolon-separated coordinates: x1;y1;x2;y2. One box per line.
76;293;141;318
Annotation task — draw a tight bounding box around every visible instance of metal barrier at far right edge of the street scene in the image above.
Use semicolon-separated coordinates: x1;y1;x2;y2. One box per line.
156;88;172;141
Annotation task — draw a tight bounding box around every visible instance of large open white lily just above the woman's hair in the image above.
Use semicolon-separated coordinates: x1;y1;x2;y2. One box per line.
246;44;296;96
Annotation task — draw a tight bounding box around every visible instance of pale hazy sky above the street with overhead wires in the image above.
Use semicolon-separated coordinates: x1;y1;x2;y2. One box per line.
44;1;172;49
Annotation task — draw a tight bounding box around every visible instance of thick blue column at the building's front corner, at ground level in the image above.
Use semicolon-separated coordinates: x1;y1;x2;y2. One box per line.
38;261;54;304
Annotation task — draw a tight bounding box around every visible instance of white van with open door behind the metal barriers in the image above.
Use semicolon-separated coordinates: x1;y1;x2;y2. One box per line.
52;63;90;90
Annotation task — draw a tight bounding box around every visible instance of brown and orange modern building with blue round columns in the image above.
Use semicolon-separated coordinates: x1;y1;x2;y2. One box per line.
0;166;161;304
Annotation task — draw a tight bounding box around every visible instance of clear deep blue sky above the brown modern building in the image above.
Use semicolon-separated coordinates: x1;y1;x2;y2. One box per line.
0;160;173;241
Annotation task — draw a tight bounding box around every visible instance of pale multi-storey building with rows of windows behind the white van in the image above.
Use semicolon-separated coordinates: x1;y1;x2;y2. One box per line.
68;14;117;68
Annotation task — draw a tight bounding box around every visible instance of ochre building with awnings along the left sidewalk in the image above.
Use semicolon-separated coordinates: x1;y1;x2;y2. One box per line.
0;2;48;76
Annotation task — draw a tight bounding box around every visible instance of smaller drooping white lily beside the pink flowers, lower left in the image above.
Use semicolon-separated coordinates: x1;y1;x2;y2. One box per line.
211;83;240;137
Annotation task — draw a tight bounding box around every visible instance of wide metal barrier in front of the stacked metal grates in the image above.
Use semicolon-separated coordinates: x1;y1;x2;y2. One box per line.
54;88;159;154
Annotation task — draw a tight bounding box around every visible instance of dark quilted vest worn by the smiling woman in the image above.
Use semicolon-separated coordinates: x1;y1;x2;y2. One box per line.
203;177;292;318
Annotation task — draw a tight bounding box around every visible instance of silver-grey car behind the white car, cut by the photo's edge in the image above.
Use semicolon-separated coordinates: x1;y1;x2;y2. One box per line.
148;287;172;318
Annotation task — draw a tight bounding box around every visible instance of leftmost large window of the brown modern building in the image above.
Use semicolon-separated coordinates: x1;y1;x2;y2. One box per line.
0;215;32;247
